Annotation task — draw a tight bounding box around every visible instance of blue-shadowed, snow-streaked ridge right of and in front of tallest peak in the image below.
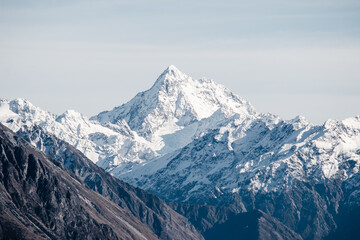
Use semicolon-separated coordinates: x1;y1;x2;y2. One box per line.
131;114;360;203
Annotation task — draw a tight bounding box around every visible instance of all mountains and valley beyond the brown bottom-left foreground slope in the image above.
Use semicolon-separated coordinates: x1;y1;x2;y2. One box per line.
0;66;360;239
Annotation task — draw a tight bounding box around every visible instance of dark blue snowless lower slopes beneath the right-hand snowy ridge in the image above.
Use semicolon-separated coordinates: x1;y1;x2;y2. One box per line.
171;179;344;239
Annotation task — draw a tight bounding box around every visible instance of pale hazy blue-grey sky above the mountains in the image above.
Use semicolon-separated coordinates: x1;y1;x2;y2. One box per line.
0;0;360;124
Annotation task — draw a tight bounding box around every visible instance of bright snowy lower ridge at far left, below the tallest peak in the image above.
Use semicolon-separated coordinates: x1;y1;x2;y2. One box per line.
0;99;157;169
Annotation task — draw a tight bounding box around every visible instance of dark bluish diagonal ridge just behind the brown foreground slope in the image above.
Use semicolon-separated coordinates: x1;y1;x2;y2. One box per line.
18;126;203;239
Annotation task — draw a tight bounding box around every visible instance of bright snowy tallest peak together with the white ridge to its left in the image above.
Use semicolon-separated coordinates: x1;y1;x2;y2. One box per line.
0;66;257;172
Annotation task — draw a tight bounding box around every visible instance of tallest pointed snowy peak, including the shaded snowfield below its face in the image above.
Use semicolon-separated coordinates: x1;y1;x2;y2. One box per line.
91;66;257;162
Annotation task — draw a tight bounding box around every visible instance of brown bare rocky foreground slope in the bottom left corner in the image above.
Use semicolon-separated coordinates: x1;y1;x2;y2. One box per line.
0;124;158;239
